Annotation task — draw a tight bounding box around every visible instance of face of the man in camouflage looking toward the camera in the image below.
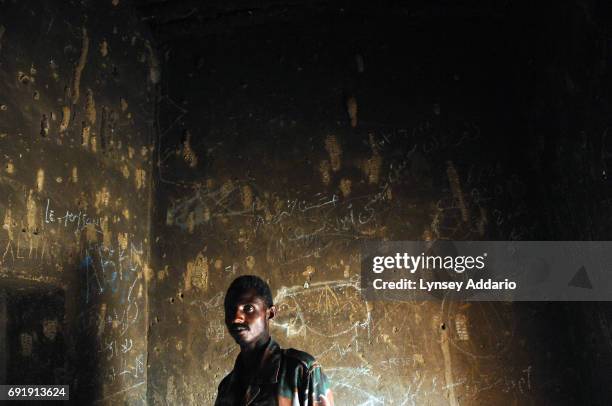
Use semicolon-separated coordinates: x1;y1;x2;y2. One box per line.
225;289;275;347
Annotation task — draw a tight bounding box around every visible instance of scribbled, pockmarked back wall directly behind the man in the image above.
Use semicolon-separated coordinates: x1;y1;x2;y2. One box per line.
143;3;611;405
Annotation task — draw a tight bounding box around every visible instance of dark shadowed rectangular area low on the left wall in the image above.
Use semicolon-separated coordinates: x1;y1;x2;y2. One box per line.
0;279;99;404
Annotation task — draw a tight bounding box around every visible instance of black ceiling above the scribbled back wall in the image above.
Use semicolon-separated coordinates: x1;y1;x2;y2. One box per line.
134;0;511;42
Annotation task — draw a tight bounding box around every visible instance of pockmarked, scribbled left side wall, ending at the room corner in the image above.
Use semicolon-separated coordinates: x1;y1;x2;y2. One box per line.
0;0;159;404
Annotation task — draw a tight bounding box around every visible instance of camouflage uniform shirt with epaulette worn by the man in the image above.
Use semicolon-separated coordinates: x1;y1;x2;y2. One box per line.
215;339;334;406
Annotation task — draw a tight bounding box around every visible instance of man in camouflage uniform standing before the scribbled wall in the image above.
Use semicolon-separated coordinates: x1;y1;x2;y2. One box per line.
215;275;334;406
